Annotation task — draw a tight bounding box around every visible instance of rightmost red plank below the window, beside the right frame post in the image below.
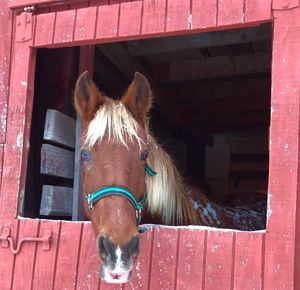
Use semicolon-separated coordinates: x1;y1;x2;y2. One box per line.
233;232;264;290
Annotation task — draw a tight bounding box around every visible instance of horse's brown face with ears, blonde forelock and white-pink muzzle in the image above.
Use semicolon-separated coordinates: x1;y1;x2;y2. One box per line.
74;73;151;283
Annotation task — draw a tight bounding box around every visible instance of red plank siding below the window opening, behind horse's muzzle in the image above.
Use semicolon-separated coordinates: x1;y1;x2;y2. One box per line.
0;219;267;290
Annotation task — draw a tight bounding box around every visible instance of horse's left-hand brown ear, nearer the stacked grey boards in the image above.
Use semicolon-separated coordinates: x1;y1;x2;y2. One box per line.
74;71;105;120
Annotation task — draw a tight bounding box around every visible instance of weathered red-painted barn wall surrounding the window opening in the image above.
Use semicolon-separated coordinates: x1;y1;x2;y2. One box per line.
0;0;300;290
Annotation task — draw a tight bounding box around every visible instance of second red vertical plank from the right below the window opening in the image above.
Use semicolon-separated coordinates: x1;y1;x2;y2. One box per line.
205;230;235;290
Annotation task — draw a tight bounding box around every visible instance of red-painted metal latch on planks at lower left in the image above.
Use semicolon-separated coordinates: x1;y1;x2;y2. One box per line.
0;227;52;255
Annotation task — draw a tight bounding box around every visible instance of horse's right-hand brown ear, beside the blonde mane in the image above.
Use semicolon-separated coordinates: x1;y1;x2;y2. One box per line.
122;72;152;122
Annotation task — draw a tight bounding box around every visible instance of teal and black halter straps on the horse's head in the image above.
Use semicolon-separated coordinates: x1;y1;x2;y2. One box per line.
85;162;157;226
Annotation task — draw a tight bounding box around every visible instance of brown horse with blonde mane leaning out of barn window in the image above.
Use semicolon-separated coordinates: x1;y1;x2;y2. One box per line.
74;72;265;283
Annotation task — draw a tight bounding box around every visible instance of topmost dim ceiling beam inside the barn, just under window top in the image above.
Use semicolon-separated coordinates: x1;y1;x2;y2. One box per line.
127;24;272;56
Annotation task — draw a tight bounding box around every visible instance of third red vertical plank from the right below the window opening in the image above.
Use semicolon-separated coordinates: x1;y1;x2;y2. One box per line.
176;229;205;290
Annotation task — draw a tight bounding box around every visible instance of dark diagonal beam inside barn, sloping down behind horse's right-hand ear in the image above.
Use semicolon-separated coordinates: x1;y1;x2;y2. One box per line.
98;43;210;140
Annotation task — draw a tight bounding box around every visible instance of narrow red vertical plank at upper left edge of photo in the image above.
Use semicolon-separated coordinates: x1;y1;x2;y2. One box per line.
0;1;13;143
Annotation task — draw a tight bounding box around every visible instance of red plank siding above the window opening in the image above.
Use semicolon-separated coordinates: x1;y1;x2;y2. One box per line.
29;0;271;47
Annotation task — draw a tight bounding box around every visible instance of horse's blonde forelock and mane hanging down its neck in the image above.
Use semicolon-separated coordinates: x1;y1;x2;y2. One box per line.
85;98;199;225
